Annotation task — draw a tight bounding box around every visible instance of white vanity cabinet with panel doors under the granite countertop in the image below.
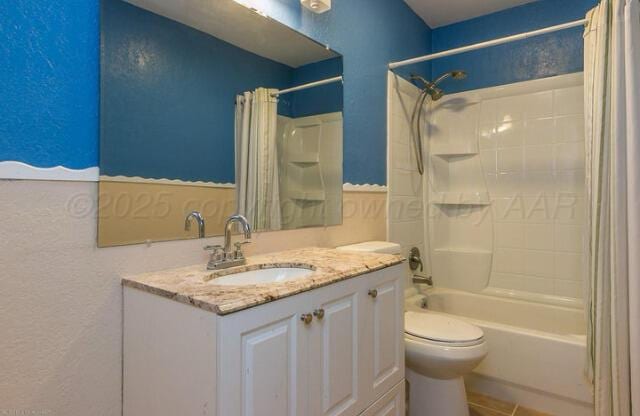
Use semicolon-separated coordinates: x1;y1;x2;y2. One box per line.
124;265;405;416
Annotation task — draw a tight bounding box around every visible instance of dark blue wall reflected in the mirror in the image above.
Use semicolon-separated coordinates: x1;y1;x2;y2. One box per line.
100;0;342;183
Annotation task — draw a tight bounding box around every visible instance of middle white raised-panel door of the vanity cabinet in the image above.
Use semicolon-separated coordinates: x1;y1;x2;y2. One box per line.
309;279;366;416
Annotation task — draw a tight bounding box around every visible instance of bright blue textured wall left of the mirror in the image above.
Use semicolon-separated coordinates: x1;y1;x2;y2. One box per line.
0;0;99;169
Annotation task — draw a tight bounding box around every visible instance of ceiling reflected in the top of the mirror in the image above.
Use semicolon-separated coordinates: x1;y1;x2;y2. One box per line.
125;0;339;68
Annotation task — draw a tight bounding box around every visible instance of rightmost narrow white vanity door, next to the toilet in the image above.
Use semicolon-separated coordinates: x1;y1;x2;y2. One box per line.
361;264;406;402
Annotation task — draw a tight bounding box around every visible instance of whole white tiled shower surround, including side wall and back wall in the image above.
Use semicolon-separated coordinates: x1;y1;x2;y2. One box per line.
388;73;585;299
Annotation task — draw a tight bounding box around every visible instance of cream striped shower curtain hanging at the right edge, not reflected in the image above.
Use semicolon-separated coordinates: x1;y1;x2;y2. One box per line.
585;0;640;416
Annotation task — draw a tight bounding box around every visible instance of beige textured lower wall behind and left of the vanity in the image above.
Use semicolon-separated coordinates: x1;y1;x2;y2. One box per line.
0;180;386;416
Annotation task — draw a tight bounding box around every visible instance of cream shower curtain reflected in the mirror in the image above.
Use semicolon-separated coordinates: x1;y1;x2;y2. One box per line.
235;88;281;230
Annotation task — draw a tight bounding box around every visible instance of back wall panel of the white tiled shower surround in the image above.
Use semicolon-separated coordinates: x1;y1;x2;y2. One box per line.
429;73;585;298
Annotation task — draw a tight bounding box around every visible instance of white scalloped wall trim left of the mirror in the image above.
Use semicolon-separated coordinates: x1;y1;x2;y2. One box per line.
0;160;100;182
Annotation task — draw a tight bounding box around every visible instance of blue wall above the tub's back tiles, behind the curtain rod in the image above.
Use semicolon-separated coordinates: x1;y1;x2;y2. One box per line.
432;0;597;92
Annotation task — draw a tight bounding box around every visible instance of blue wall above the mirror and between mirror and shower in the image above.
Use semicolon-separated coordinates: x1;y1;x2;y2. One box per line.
242;0;431;184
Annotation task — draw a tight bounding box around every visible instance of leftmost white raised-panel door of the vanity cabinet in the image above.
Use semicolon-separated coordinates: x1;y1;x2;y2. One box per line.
218;294;311;416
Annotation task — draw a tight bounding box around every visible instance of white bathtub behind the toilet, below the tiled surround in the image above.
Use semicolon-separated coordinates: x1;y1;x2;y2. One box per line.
407;288;593;416
